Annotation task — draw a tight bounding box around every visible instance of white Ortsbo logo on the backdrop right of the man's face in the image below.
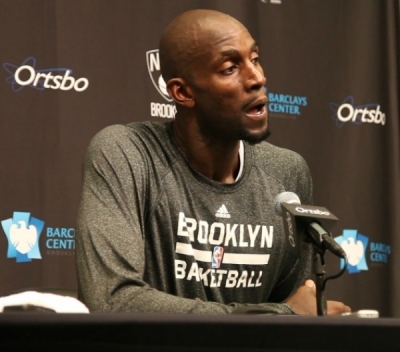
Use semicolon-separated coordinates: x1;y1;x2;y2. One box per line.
329;96;386;127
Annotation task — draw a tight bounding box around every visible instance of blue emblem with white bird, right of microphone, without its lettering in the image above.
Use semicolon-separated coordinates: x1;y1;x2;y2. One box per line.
335;230;369;274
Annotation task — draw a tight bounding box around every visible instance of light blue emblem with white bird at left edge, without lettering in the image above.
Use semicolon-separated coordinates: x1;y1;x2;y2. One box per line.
1;212;44;263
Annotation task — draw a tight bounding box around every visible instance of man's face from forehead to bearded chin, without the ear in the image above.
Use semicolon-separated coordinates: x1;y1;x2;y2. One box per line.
188;24;269;143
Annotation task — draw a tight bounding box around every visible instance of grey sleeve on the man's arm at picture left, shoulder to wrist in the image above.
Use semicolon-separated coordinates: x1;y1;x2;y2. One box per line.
76;126;304;314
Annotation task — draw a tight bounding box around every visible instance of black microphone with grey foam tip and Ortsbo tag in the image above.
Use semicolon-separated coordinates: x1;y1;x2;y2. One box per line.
274;192;346;258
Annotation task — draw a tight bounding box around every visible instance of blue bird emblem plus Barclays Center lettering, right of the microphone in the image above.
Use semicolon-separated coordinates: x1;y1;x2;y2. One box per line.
335;229;392;274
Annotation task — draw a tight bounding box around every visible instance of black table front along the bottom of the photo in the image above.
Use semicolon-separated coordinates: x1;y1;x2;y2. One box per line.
0;312;400;352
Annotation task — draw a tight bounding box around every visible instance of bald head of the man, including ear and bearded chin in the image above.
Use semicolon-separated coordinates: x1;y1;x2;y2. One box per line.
160;10;268;143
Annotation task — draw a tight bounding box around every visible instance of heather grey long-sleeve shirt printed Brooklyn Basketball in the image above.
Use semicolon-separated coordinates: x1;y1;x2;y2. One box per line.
76;122;312;314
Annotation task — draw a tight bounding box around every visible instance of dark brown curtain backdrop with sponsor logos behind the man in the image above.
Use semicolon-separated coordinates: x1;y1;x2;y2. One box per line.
0;0;400;316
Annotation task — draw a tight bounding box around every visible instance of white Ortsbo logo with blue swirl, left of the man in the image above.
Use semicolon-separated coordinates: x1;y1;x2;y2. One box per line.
3;56;89;92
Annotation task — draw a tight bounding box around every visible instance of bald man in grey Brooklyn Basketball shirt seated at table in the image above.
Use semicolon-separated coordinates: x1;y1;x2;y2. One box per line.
76;10;349;315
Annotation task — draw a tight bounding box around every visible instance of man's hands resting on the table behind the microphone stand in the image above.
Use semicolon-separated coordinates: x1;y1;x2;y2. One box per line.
285;280;351;315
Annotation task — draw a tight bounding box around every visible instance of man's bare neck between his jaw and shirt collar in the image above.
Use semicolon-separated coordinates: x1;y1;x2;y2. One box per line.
172;121;240;183
